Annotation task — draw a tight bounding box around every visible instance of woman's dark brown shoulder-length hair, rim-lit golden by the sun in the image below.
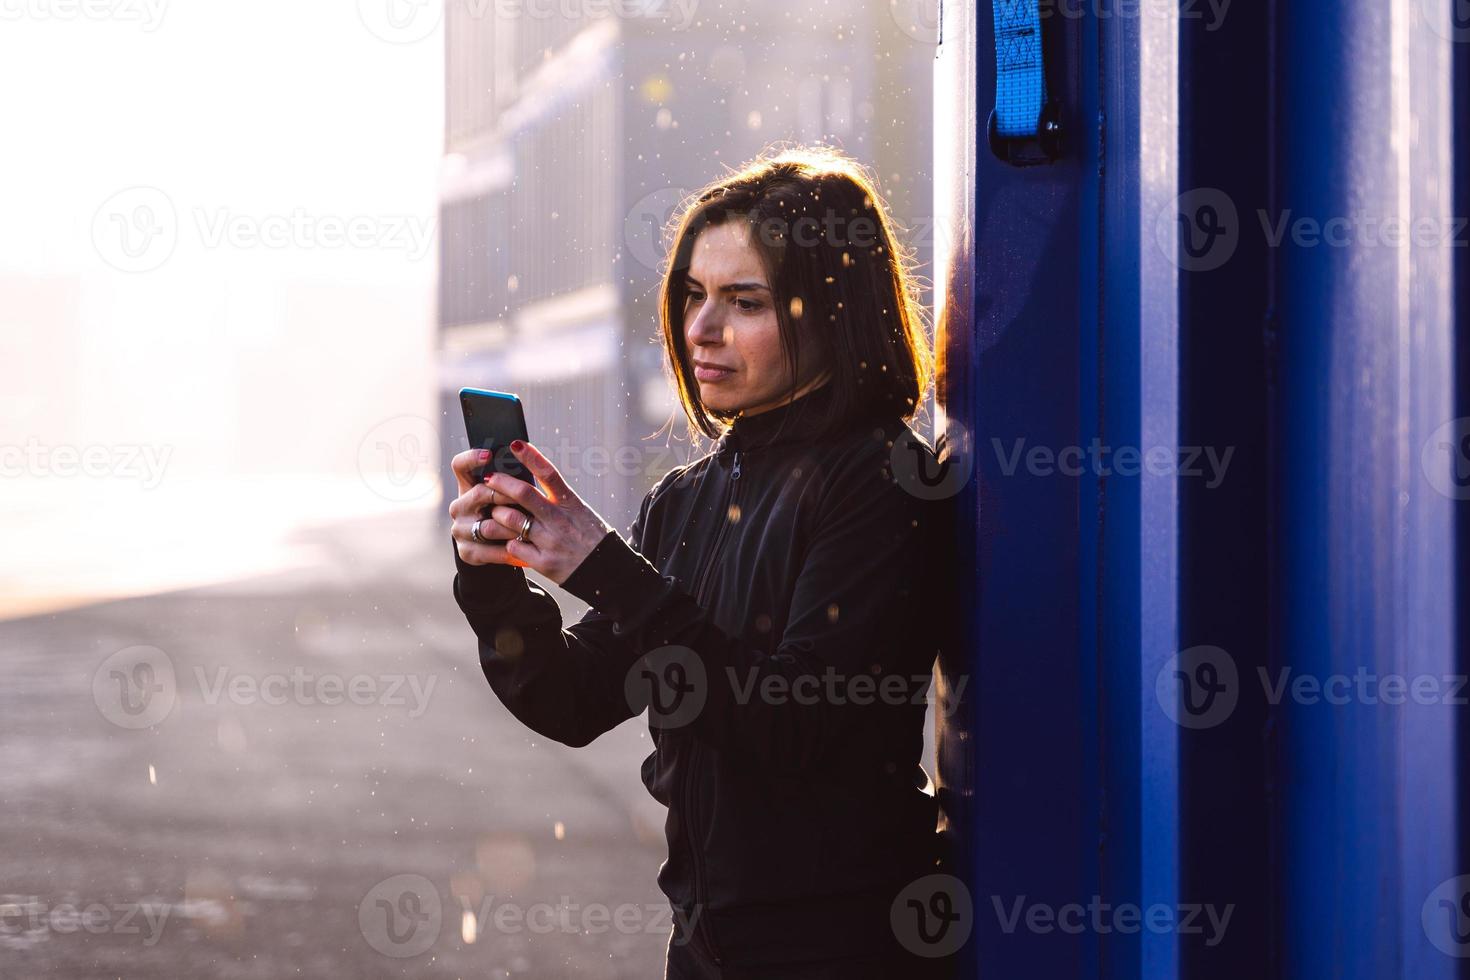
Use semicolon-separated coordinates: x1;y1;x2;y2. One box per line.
659;145;933;438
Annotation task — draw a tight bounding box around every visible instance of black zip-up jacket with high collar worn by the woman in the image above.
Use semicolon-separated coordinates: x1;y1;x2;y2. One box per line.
454;385;953;964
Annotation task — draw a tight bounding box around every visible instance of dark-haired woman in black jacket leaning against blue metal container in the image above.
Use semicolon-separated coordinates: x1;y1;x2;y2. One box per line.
450;148;950;979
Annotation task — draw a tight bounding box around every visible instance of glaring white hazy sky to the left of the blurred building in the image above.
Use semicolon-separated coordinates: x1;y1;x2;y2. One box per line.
0;0;442;614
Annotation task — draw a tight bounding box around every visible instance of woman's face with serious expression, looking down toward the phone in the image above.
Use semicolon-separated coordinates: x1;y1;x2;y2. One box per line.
684;220;828;416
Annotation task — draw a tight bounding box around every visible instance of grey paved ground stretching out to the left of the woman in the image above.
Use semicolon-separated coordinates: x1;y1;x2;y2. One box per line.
0;519;667;980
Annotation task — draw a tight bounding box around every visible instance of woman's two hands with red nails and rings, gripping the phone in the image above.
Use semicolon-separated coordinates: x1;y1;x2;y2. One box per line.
450;439;613;585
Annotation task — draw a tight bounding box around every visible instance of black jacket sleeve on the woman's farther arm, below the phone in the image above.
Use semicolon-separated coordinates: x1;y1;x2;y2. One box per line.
450;488;657;746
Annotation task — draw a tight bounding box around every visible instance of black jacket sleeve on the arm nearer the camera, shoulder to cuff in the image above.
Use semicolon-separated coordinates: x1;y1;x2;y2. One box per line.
552;443;954;773
